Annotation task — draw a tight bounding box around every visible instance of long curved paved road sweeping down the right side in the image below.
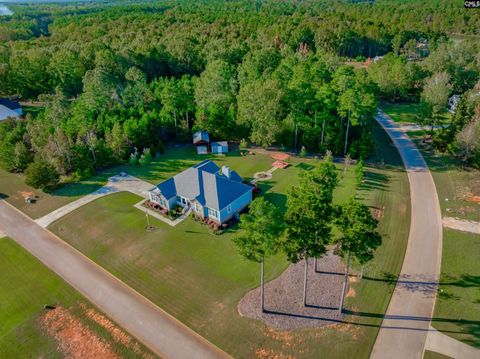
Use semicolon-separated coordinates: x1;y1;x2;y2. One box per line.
371;111;442;359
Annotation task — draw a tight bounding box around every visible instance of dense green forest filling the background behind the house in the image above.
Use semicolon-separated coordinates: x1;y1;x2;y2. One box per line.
0;0;480;186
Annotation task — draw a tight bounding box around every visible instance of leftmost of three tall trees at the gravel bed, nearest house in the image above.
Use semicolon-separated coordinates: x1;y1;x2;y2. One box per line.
233;197;283;312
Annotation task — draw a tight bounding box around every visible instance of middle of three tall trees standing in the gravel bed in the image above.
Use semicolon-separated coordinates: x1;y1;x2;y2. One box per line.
283;160;338;305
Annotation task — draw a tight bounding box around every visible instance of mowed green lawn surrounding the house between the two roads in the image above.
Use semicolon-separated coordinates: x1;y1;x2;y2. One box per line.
47;124;409;358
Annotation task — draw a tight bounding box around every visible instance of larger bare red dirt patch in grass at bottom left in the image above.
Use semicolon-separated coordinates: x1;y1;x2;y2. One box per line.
40;307;118;359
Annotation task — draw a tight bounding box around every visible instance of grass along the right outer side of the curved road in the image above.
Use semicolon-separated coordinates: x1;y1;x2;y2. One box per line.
386;104;480;347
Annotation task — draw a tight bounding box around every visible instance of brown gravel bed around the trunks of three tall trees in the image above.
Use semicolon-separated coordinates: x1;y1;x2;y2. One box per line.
238;252;346;330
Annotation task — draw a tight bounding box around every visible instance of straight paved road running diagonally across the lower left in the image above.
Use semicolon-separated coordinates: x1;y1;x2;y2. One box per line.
0;200;229;359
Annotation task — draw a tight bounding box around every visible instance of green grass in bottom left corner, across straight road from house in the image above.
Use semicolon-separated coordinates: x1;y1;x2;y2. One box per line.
0;238;154;358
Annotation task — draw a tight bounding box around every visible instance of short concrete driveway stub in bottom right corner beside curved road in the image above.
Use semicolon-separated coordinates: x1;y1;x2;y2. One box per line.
425;327;480;359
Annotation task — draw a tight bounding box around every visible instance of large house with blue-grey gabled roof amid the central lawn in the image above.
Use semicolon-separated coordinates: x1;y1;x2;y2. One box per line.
149;160;253;224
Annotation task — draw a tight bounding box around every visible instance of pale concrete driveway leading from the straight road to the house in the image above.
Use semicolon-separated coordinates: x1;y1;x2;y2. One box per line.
35;175;153;228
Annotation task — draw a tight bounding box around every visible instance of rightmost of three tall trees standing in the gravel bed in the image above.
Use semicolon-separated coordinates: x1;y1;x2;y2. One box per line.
336;199;382;313
